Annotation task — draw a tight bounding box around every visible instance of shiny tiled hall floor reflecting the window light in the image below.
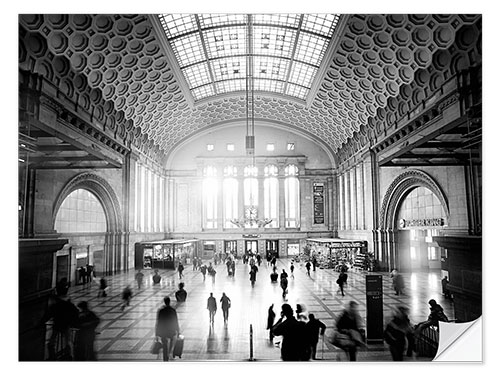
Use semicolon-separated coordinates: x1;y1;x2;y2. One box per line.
62;259;454;362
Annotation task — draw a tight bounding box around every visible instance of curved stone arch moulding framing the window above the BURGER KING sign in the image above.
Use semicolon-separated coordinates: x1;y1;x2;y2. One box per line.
379;169;450;229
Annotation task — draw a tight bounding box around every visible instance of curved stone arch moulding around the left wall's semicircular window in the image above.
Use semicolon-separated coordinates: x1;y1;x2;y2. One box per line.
52;172;123;232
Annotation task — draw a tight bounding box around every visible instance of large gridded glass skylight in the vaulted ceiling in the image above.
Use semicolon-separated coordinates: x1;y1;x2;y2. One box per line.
159;14;339;101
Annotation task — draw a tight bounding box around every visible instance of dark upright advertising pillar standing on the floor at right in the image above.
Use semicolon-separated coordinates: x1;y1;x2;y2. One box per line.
366;275;384;343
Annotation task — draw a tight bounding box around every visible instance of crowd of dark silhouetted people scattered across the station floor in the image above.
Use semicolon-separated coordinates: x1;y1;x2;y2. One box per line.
44;254;449;361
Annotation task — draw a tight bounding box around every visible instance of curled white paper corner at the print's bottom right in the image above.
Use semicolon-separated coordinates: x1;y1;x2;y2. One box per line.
433;317;483;362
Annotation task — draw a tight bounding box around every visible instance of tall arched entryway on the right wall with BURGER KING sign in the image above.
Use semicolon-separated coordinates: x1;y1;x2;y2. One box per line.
377;170;449;271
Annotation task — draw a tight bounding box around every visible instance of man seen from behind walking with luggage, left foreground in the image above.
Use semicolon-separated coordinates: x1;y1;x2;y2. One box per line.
155;297;180;361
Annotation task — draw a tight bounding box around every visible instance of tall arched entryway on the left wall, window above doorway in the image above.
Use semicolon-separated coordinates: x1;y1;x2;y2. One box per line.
52;173;127;282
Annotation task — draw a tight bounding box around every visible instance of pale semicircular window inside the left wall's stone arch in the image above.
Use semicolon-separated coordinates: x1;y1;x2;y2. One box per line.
55;189;107;233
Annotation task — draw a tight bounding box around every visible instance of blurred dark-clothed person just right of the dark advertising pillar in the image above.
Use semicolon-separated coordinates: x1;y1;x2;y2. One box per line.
384;306;413;361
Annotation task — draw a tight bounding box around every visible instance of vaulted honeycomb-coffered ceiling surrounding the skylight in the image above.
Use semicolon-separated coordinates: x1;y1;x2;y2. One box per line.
19;14;481;163
